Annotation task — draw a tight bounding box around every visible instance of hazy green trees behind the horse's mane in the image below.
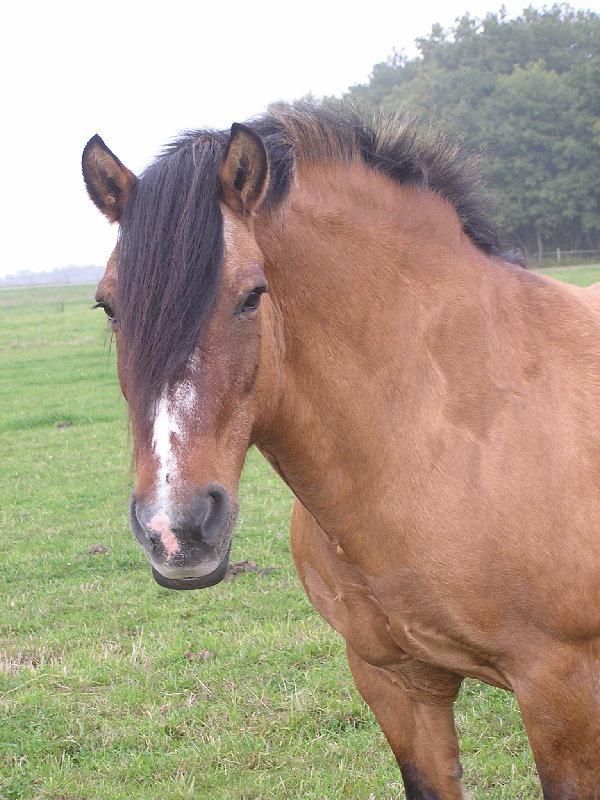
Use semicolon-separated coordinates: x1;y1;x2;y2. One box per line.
332;5;600;262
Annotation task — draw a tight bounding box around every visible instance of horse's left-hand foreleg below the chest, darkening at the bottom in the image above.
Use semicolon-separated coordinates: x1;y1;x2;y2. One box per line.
347;646;464;800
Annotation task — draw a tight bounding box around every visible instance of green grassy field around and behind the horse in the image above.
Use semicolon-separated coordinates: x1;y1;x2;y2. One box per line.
0;268;600;800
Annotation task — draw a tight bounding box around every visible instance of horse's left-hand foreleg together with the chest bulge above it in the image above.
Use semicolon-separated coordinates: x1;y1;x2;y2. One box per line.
292;502;464;800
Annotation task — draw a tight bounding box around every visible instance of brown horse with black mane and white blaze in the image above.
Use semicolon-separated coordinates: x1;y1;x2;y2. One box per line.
83;106;600;800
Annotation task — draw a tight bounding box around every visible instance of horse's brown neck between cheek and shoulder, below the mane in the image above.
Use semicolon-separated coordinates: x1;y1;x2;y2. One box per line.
257;167;524;527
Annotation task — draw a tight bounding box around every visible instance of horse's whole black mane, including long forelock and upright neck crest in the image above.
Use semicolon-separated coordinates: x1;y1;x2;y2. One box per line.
117;103;521;431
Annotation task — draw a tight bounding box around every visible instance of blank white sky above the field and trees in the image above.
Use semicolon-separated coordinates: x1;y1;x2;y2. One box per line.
0;0;600;275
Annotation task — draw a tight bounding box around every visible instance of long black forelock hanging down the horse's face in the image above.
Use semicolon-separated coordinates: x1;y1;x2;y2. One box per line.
117;137;223;433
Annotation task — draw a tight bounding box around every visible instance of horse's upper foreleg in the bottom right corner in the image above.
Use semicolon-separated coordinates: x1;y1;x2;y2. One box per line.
512;641;600;800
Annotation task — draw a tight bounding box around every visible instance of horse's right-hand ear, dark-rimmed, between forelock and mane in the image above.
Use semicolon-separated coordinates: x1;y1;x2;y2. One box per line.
219;122;269;214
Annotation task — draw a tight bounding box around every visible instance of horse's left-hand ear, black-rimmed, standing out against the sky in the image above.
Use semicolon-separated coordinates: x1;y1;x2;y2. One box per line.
81;134;137;222
